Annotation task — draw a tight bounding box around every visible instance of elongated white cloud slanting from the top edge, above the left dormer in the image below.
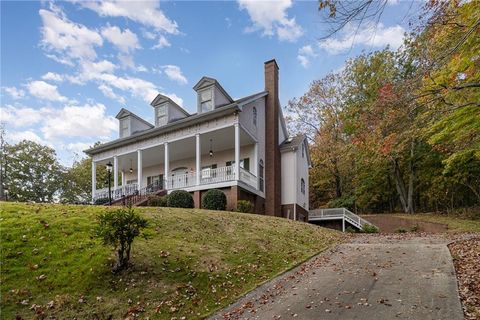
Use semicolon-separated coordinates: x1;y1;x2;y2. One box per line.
79;0;180;34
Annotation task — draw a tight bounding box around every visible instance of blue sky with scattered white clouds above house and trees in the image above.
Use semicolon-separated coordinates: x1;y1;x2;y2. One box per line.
0;0;421;165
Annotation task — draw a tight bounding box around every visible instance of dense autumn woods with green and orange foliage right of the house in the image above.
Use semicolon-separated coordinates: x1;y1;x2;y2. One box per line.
287;1;480;213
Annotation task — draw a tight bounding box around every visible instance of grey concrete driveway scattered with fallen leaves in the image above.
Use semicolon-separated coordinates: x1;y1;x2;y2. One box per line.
212;235;463;320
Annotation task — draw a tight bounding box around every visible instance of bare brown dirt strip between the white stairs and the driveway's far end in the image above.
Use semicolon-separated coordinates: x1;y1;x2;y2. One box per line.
363;214;448;233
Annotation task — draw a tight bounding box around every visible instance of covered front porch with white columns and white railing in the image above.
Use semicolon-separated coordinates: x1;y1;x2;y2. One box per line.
92;124;263;202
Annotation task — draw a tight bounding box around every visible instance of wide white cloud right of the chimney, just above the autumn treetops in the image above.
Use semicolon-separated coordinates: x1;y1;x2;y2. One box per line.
319;23;405;54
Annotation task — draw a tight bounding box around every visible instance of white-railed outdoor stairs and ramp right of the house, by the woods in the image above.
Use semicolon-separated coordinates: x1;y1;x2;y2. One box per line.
308;208;375;232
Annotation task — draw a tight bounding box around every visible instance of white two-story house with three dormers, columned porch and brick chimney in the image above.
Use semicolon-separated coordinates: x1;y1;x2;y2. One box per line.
85;60;310;220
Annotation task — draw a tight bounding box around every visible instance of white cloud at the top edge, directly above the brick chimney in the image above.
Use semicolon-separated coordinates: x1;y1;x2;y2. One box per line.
238;0;303;42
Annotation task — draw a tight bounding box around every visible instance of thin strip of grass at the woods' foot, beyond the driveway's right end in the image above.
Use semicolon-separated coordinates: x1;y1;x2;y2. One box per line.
396;213;480;232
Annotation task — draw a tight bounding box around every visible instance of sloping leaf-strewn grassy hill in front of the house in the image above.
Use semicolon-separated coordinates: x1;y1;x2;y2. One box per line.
0;203;342;319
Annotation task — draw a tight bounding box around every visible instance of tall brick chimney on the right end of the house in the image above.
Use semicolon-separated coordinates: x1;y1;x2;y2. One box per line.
265;59;282;216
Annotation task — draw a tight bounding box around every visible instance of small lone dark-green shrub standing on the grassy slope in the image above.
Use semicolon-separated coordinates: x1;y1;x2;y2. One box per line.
95;206;148;272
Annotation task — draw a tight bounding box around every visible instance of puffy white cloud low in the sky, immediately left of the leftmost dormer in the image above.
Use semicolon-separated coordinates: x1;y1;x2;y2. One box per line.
41;103;118;140
